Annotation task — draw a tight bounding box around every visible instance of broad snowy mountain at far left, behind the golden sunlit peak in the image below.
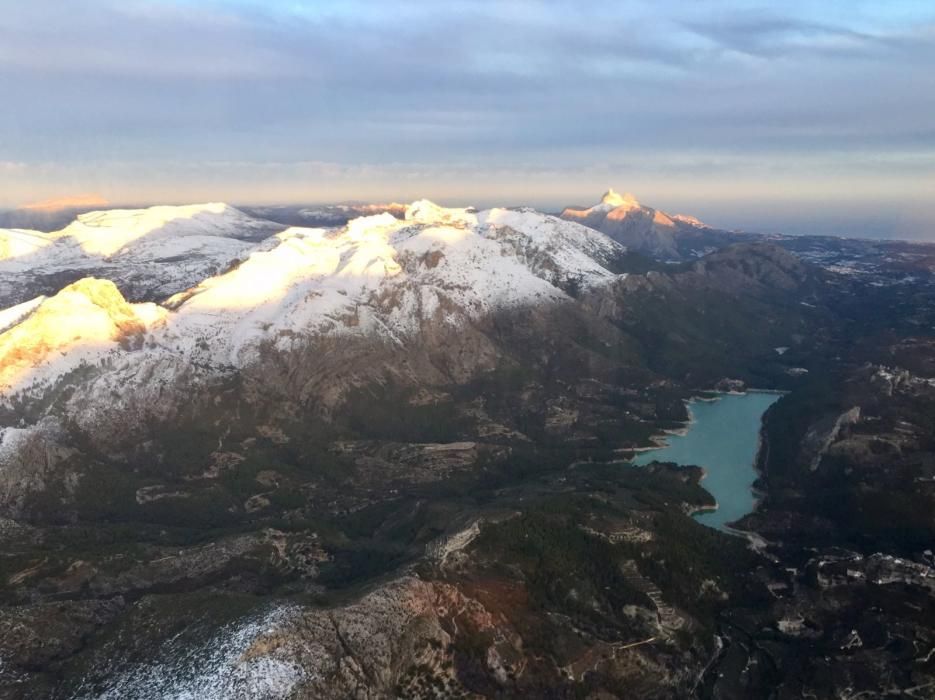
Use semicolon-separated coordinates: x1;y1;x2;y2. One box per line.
0;204;283;308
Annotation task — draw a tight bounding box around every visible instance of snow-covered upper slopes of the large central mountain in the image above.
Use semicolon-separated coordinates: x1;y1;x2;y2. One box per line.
160;201;623;365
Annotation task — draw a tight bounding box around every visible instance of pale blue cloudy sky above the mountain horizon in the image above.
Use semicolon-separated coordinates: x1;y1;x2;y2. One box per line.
0;0;935;240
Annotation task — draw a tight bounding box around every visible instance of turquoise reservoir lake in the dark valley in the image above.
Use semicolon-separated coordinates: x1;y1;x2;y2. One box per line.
633;392;780;530
